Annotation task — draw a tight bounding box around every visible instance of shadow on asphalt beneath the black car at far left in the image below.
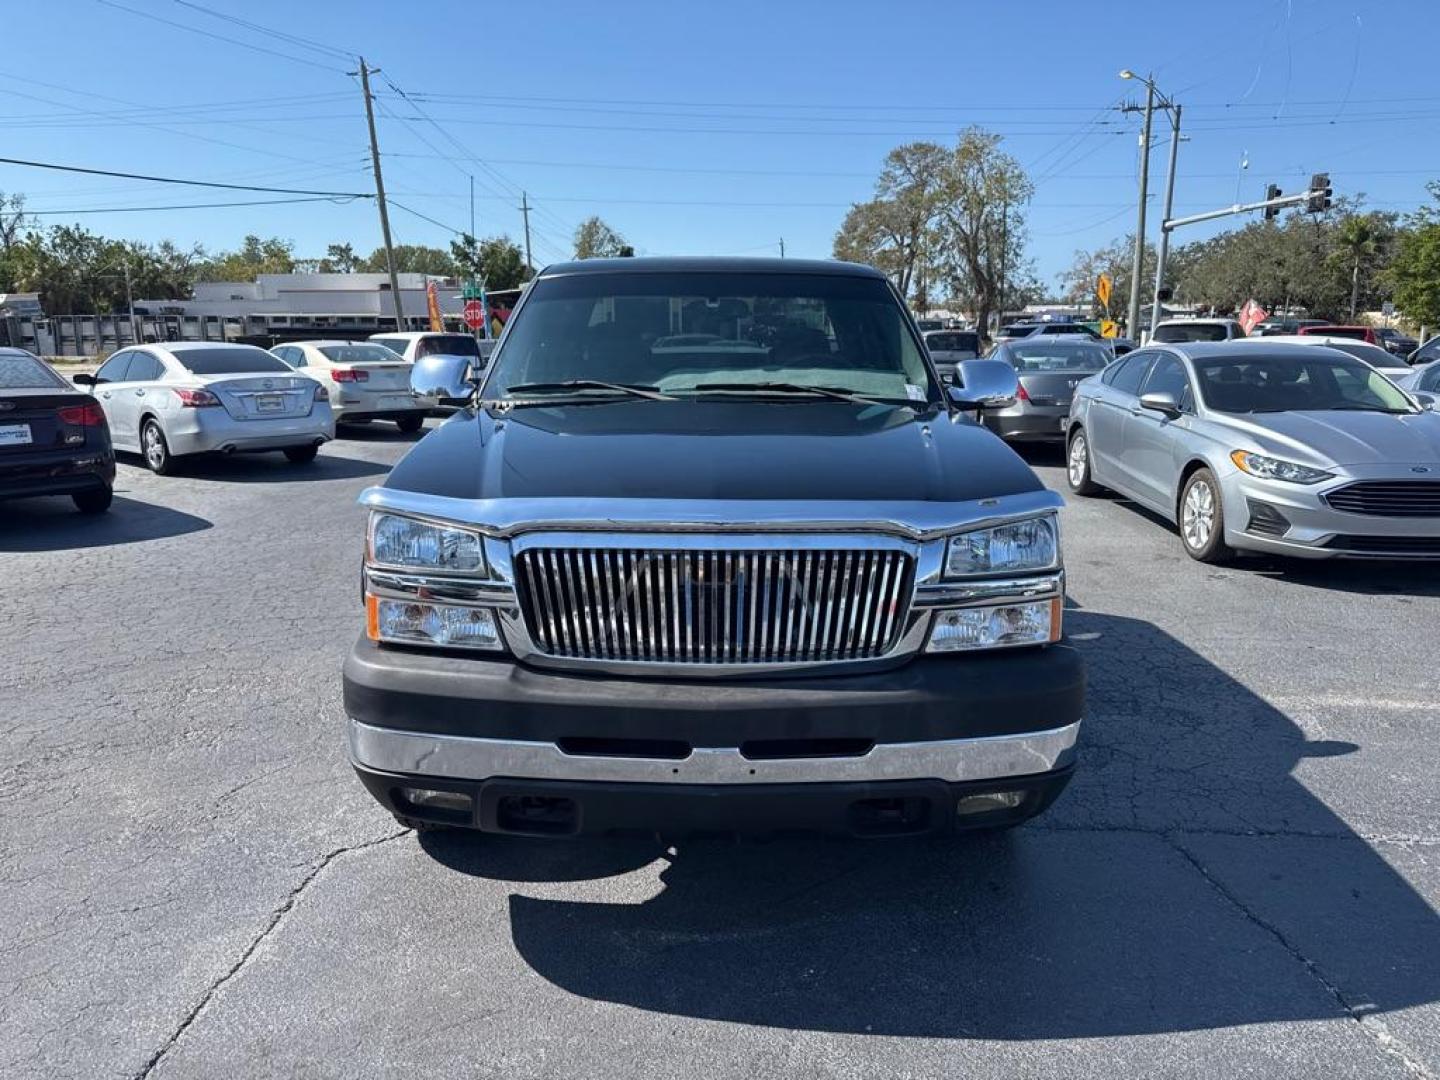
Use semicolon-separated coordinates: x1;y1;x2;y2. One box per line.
0;495;210;553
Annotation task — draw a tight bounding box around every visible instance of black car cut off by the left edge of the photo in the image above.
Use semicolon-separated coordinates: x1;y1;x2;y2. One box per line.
0;348;115;514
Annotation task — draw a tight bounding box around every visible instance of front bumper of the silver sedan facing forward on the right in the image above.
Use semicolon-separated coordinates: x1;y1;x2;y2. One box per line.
1221;465;1440;559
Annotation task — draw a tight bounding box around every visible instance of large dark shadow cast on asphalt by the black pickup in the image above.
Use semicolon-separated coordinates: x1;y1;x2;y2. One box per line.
423;611;1440;1040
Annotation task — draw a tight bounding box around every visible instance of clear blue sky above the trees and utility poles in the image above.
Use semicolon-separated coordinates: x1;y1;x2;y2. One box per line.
0;0;1440;285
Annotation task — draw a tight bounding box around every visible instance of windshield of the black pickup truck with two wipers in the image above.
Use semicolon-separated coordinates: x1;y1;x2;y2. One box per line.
484;272;939;402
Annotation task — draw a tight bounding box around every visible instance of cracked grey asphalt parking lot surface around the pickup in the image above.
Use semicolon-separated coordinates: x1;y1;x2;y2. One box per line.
0;425;1440;1080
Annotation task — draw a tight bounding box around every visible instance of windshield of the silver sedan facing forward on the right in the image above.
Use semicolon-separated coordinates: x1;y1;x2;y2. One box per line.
1194;348;1416;413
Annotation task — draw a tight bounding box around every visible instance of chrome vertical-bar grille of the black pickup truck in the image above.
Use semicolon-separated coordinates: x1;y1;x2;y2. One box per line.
516;547;914;664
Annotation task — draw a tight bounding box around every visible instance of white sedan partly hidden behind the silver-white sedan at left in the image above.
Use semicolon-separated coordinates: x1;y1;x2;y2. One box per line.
271;341;428;433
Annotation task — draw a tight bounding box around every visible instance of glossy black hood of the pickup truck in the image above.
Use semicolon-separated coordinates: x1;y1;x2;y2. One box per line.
384;400;1043;503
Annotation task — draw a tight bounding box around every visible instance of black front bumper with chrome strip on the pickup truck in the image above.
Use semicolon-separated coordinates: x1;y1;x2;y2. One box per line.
344;639;1084;834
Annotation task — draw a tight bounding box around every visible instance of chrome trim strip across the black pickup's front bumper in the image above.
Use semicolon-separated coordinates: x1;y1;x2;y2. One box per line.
348;720;1080;783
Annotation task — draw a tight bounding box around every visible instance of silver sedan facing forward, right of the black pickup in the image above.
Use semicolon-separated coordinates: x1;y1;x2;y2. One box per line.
1067;341;1440;562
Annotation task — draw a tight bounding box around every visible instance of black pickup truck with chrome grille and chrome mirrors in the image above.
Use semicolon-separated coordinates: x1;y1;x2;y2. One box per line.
344;258;1084;835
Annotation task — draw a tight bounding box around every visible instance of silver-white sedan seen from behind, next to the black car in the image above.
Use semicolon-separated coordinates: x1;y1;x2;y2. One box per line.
75;341;336;474
